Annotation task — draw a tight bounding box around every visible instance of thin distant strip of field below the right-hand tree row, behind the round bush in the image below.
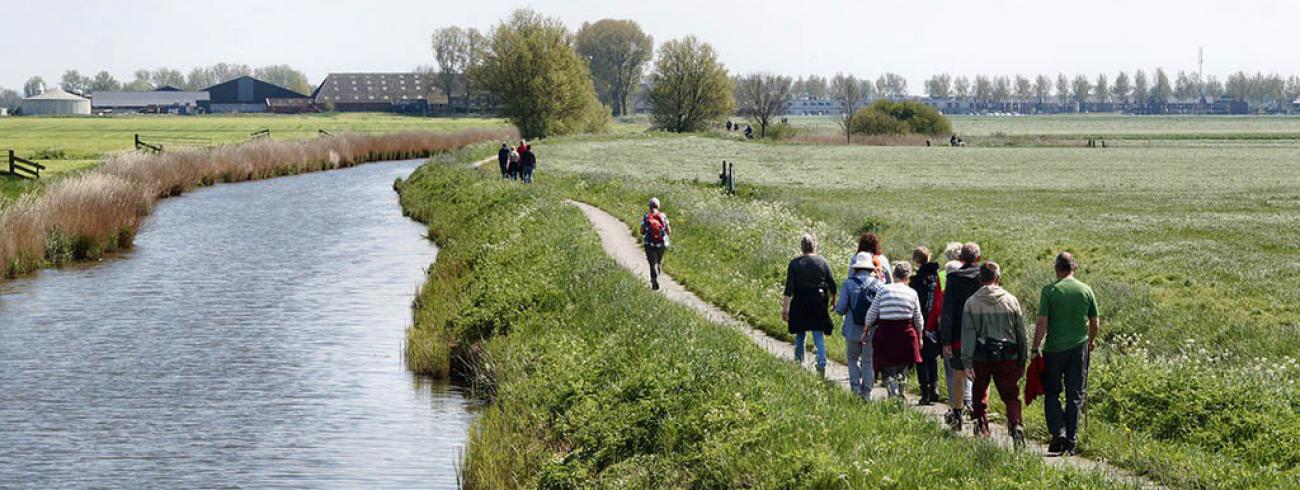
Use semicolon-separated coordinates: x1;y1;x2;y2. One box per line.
789;114;1300;140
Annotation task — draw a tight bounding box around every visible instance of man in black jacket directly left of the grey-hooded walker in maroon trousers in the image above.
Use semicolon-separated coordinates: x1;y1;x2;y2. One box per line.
939;242;983;432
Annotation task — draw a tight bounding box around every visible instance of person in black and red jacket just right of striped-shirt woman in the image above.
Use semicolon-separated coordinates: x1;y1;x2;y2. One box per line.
907;246;944;406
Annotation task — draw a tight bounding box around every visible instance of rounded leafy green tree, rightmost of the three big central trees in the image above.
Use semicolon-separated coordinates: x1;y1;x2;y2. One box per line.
650;36;736;133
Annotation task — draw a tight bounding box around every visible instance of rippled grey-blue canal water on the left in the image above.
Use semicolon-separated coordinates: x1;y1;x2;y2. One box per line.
0;161;472;489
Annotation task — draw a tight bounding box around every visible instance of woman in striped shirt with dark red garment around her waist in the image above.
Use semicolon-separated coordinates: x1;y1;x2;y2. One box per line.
863;263;926;400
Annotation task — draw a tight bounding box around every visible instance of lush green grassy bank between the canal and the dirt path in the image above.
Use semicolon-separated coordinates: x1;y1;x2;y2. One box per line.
399;165;1108;489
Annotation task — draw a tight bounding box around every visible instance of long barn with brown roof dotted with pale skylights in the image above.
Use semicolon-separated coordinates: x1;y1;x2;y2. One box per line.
312;73;447;114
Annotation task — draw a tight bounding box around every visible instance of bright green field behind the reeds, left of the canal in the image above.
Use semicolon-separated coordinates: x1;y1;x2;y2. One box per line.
0;113;506;173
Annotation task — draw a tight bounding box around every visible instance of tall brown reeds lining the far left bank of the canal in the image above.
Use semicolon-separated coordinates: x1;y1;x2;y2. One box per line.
0;129;519;278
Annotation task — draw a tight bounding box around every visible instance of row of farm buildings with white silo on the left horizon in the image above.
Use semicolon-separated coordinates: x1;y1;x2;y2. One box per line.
20;73;457;116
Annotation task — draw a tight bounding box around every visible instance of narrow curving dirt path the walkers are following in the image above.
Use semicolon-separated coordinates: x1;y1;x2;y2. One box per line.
569;200;1164;489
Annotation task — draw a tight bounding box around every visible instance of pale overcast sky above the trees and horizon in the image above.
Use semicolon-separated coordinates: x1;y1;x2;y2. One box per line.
0;0;1300;94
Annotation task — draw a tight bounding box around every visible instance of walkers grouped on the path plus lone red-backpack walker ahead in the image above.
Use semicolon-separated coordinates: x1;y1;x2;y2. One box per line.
641;199;1100;455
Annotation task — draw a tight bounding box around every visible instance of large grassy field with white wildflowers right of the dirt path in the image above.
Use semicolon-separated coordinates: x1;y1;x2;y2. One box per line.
514;124;1300;487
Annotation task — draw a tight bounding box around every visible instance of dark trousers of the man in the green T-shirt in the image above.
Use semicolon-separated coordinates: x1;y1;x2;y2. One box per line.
1043;344;1088;442
